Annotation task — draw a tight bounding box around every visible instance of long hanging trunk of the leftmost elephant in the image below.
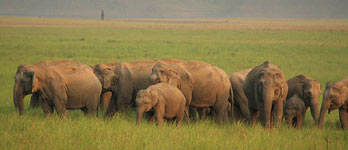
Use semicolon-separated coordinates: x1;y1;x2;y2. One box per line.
13;80;25;115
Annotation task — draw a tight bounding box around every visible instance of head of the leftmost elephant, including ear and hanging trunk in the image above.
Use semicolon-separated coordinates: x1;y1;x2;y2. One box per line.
13;65;40;115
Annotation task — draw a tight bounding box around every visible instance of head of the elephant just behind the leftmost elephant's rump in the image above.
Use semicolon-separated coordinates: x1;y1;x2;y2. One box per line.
94;64;118;92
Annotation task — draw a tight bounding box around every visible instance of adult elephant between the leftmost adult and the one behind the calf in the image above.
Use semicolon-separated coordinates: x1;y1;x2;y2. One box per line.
94;59;183;117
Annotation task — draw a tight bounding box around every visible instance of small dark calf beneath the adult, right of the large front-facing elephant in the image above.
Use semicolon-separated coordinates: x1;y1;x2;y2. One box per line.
284;95;306;129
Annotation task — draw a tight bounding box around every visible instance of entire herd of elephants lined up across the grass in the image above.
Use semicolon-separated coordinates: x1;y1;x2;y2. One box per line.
13;59;348;129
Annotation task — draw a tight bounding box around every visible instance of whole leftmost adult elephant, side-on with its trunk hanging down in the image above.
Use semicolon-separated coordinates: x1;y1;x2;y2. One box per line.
13;61;102;117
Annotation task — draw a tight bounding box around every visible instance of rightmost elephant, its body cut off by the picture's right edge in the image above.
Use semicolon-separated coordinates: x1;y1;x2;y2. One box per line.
318;77;348;130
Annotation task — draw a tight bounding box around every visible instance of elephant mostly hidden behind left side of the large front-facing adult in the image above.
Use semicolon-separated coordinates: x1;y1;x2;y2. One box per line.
229;69;251;120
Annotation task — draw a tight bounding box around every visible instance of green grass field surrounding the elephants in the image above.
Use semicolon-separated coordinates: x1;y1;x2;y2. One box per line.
0;17;348;150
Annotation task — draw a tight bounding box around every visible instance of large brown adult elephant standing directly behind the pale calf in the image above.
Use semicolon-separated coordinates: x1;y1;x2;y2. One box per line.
149;61;232;123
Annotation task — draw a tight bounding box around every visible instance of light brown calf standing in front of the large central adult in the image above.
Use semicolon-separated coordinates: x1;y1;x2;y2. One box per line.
135;83;188;126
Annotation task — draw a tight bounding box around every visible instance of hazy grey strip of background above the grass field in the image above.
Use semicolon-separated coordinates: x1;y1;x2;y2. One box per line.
0;0;348;19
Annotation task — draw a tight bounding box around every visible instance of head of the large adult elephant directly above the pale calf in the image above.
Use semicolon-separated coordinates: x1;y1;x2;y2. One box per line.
149;64;181;88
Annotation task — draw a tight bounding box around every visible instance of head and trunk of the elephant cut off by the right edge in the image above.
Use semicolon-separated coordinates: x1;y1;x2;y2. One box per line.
318;78;348;128
